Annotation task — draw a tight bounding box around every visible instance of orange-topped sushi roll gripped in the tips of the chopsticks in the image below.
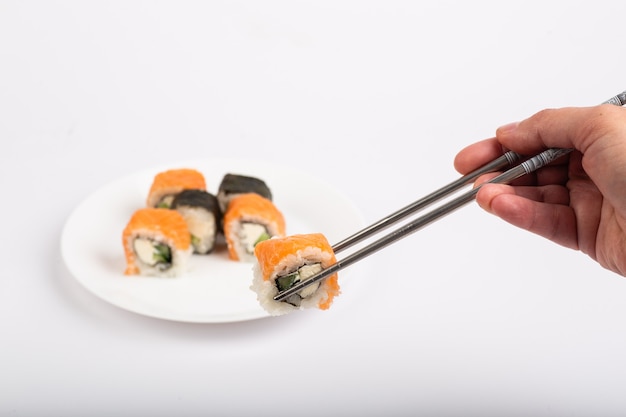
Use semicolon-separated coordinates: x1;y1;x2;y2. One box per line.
250;233;340;316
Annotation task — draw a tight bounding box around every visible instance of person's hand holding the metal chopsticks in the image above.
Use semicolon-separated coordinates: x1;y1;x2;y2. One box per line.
454;104;626;276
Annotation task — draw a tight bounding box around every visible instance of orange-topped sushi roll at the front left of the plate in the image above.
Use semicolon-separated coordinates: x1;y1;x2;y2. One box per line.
122;208;192;277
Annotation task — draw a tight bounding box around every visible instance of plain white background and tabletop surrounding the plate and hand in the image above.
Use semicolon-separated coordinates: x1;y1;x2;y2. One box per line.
0;0;626;417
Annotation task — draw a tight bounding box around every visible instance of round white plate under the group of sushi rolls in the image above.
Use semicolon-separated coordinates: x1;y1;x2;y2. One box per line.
61;159;363;323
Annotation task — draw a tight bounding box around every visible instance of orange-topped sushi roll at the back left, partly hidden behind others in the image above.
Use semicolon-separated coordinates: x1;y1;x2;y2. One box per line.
146;168;206;208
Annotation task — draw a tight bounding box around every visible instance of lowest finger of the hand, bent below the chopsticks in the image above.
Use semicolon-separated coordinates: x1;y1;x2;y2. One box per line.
476;184;578;249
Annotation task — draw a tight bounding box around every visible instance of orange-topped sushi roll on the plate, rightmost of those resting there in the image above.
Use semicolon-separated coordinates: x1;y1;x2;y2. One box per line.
224;193;285;262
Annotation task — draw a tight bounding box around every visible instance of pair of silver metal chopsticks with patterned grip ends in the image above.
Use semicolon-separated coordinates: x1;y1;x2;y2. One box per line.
274;91;626;301
